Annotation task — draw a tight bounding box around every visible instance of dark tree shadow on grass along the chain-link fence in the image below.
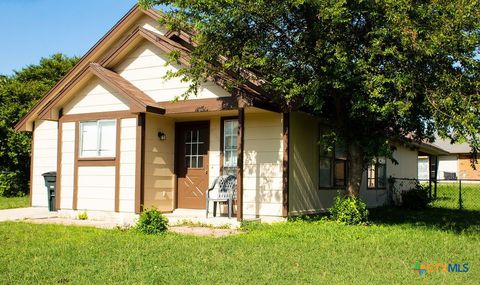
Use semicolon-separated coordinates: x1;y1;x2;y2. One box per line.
369;207;480;234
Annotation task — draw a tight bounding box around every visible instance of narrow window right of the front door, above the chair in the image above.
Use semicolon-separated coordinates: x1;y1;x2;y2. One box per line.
223;119;238;175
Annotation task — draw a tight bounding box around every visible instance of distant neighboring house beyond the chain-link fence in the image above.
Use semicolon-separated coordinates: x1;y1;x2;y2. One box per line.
418;138;480;180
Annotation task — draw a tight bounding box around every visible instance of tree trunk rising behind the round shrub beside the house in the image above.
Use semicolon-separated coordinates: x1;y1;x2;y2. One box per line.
347;142;365;197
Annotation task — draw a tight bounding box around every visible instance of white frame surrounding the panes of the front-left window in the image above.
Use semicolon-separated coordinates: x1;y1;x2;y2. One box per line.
78;119;117;158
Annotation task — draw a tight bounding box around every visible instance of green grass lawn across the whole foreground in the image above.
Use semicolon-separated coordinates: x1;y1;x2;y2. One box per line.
0;206;480;284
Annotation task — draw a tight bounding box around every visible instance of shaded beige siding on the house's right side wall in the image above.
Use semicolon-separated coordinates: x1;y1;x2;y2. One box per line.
289;113;418;215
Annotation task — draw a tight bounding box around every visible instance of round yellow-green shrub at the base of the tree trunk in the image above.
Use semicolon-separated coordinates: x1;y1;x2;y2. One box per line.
328;195;368;225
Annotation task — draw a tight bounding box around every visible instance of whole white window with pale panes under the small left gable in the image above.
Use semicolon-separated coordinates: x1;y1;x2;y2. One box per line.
79;120;116;158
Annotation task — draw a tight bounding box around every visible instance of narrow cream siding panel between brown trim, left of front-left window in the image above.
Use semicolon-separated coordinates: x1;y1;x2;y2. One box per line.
60;122;75;209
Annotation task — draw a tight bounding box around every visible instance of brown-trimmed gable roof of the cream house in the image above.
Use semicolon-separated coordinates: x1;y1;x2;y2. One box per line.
15;5;280;131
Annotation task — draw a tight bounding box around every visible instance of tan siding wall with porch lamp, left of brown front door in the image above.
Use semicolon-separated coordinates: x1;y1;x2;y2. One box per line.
144;114;175;211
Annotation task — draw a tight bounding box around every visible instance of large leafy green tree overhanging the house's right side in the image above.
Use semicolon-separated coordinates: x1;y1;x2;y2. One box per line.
139;0;480;195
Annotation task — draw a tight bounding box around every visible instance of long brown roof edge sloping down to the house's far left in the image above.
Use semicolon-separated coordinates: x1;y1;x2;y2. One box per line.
15;4;161;131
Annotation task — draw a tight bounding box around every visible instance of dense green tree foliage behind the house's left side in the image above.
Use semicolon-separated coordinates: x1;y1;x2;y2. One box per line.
0;54;78;196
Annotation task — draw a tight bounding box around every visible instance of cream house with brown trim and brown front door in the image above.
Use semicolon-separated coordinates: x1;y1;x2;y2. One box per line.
17;6;428;220
